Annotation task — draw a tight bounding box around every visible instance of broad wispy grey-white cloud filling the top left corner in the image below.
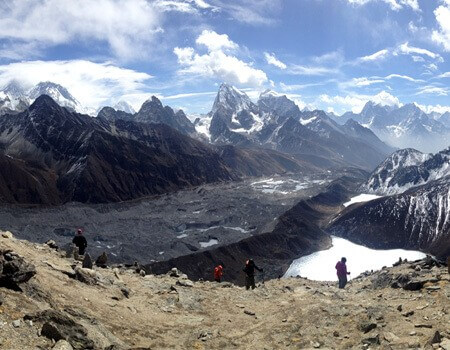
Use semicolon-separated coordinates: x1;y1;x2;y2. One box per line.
0;0;161;58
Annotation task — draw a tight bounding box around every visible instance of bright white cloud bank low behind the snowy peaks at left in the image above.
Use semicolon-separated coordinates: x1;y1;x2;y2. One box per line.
0;60;151;108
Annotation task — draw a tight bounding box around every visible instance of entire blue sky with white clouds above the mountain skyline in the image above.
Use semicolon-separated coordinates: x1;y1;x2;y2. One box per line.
0;0;450;114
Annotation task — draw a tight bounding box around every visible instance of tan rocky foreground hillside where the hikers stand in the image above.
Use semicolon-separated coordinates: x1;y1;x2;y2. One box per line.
0;232;450;350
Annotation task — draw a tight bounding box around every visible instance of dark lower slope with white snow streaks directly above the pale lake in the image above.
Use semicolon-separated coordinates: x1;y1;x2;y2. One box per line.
328;176;450;258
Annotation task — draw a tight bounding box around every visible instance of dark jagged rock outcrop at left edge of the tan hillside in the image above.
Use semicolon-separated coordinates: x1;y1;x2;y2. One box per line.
0;250;36;291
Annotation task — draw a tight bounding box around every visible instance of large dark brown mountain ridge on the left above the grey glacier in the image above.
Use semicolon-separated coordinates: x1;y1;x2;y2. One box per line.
0;95;237;204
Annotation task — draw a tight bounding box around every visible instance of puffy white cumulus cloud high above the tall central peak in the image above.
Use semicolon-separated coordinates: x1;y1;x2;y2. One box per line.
173;31;268;86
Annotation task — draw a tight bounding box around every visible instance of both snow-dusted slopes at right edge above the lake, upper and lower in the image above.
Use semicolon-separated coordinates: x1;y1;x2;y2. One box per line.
328;148;450;258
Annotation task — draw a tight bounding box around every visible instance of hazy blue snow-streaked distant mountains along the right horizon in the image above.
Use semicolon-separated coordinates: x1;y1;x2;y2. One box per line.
340;101;450;152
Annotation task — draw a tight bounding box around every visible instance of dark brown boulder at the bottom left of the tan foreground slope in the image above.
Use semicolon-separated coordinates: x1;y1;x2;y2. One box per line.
24;309;96;350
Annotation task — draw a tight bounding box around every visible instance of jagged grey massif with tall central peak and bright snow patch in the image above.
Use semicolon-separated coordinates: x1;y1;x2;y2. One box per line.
209;84;393;169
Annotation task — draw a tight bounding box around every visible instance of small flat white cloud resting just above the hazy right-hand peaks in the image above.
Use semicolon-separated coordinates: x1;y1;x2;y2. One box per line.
318;91;401;113
